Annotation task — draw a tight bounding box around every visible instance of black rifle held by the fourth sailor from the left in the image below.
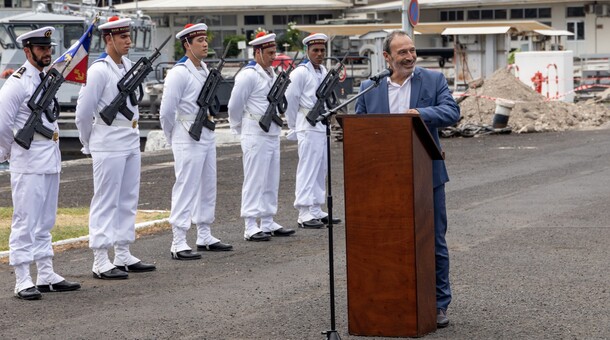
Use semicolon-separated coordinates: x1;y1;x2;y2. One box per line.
258;52;299;132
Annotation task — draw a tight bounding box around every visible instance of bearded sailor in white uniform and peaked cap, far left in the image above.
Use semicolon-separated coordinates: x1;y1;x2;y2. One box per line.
0;27;80;300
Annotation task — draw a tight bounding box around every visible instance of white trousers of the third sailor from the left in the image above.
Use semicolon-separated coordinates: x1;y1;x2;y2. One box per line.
169;140;219;252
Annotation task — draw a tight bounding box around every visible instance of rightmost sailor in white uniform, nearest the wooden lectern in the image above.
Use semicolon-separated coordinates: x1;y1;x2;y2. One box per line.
286;33;341;228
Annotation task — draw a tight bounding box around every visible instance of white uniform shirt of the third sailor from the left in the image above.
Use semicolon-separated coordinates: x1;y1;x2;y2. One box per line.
159;59;214;144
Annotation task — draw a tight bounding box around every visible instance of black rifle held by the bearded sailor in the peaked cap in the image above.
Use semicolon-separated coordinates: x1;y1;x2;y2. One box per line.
15;68;64;150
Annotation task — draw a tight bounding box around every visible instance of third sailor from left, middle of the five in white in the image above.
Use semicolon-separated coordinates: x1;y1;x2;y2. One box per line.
160;23;233;260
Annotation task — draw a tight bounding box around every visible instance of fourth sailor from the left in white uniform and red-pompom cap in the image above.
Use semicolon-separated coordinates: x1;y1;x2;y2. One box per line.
228;32;294;241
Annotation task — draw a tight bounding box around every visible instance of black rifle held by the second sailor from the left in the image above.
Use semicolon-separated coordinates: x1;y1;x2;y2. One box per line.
100;35;172;125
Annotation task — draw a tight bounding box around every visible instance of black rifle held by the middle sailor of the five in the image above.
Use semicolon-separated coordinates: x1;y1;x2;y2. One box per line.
189;42;231;141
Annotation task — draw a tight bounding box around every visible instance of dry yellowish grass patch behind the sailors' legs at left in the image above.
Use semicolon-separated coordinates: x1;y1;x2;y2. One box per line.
0;207;169;251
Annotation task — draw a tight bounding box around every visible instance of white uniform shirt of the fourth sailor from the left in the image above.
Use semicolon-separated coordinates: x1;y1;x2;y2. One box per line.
228;62;281;136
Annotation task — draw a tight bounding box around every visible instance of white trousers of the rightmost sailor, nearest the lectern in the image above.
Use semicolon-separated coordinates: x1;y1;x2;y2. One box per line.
294;131;327;222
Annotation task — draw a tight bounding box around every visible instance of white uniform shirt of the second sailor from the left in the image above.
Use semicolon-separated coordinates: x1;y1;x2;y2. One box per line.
76;54;140;154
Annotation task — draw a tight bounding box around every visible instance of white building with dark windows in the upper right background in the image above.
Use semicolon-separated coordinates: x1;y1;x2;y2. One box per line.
349;0;610;56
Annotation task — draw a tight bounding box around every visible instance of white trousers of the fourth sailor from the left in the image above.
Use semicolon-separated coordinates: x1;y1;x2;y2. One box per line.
241;135;280;218
